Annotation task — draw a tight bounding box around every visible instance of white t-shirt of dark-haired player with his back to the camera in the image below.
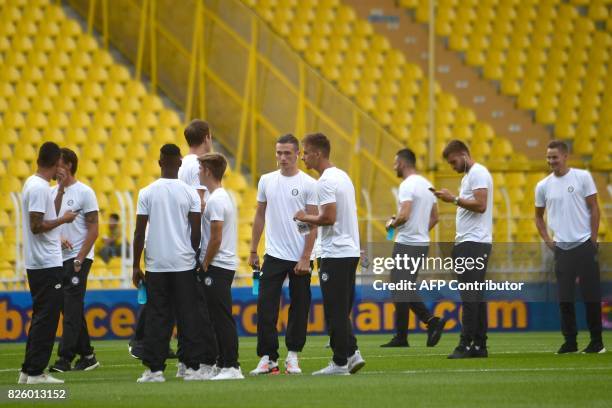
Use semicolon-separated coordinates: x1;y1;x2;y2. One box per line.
136;178;201;272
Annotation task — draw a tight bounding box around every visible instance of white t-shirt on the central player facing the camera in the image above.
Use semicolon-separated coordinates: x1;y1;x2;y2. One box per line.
257;170;318;262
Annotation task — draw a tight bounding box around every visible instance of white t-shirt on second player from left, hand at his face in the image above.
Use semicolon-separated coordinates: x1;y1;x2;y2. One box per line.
51;181;99;261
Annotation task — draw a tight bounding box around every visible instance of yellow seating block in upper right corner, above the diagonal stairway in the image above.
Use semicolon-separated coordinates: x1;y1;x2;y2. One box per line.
400;0;612;171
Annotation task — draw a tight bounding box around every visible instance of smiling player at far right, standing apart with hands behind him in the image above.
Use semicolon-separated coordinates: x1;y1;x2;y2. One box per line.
535;141;606;354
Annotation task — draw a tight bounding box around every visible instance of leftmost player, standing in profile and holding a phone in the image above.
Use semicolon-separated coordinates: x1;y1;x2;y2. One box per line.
18;142;77;384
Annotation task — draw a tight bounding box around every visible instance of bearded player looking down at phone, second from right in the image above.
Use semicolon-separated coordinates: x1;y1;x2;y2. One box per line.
434;140;493;359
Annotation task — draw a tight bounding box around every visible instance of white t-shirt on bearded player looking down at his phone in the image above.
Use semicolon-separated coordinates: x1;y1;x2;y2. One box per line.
455;163;493;243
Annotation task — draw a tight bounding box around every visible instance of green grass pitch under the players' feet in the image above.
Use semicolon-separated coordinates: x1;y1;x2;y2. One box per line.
0;332;612;408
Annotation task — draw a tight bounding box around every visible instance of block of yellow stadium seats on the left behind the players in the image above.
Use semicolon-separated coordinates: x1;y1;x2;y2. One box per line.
0;0;254;289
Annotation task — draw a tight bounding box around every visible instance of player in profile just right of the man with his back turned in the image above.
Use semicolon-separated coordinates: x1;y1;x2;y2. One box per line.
198;153;244;380
